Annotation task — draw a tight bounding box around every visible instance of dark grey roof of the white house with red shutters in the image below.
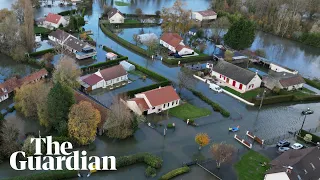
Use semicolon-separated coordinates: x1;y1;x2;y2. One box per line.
212;60;256;85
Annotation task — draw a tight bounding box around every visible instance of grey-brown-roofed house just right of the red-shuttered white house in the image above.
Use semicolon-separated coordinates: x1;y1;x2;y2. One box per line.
262;71;305;91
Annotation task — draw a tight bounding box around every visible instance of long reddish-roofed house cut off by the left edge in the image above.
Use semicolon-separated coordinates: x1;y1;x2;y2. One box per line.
0;68;48;102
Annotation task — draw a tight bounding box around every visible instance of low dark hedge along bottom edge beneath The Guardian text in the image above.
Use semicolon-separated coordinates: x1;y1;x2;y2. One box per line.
7;170;78;180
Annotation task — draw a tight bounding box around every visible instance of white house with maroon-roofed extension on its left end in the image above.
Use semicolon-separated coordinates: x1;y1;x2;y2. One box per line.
79;65;128;91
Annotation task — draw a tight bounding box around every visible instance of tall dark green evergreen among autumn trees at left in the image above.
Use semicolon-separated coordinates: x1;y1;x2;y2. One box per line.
47;83;75;135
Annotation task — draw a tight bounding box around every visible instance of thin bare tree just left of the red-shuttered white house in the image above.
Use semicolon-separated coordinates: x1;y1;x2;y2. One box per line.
178;67;197;94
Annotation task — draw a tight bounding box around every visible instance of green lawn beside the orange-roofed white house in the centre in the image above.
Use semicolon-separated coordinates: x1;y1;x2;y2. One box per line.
169;103;211;120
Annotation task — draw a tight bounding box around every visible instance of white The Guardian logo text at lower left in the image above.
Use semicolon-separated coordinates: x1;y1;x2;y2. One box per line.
10;136;117;171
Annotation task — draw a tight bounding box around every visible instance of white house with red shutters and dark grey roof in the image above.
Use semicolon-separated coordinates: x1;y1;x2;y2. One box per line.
207;60;261;93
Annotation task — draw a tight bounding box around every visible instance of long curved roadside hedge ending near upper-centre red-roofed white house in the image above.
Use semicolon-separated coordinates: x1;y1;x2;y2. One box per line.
99;23;149;57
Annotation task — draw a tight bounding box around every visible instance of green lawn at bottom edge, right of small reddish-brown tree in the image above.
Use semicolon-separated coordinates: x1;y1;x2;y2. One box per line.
234;150;270;180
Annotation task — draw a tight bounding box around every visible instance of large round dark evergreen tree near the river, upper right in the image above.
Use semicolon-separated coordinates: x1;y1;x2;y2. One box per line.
224;18;255;50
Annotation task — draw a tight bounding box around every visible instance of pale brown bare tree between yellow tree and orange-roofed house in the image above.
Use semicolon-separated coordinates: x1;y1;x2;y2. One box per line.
103;97;134;139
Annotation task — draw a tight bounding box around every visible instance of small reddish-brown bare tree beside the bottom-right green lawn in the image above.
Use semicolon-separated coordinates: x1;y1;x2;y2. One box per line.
210;142;235;168
